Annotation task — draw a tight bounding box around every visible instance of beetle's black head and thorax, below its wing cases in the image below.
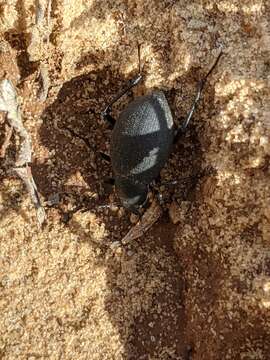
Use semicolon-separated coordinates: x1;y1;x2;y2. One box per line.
115;178;148;215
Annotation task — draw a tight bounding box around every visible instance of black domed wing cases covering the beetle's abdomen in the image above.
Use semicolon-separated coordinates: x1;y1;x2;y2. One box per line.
111;91;174;185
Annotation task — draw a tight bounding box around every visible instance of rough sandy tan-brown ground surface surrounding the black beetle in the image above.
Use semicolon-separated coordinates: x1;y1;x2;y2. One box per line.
0;0;270;360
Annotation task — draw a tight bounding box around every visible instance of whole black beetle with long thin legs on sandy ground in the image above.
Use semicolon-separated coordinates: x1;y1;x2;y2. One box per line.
101;46;222;215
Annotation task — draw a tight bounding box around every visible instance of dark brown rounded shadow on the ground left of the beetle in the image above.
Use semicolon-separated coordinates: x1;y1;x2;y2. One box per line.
35;68;138;240
